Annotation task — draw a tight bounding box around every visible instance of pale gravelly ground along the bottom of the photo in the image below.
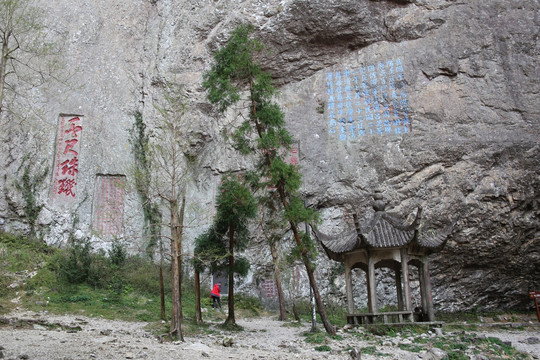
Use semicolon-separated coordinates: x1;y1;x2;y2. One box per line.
0;311;540;360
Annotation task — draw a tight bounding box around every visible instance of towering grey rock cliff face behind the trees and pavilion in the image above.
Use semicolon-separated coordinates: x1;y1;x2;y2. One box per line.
0;0;540;310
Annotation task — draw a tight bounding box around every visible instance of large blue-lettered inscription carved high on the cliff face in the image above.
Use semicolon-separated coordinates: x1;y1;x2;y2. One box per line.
325;58;411;141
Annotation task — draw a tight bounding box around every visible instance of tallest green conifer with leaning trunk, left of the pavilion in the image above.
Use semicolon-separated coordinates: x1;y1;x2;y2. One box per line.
203;25;335;334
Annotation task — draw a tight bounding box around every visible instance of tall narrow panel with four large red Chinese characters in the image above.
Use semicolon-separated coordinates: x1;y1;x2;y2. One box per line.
53;115;83;200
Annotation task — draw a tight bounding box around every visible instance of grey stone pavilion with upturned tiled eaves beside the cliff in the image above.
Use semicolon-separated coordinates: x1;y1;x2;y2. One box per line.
315;191;453;324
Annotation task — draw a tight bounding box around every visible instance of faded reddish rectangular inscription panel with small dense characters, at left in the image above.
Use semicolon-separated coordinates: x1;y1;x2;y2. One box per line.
93;175;126;236
